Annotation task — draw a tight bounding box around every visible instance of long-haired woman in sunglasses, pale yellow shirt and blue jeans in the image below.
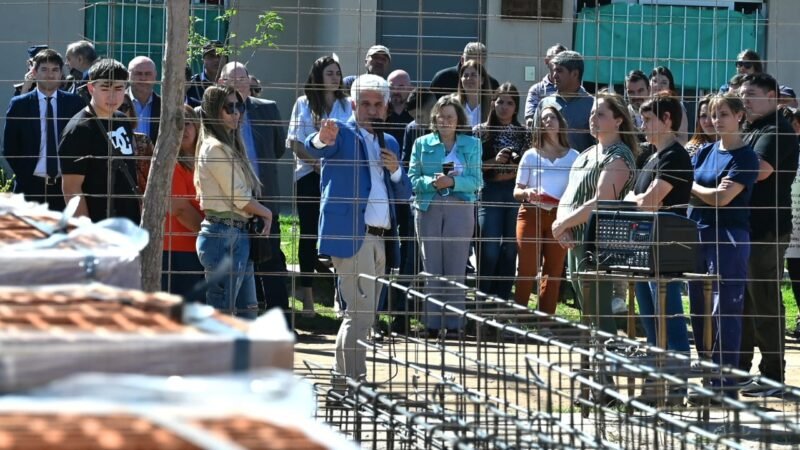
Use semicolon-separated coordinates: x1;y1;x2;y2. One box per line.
194;86;272;318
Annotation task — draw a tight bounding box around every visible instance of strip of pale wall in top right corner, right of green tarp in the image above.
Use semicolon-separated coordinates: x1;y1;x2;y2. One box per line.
766;0;800;89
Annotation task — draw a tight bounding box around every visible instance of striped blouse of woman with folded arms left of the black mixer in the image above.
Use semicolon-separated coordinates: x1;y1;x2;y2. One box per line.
558;142;636;242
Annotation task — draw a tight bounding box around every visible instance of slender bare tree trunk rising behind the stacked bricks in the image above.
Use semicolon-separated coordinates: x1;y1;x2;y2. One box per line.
142;0;189;291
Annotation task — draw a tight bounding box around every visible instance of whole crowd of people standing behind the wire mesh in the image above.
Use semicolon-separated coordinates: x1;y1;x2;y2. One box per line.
4;41;800;396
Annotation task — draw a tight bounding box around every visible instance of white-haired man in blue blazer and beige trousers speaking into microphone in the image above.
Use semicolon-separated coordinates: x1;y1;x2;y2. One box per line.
305;74;411;388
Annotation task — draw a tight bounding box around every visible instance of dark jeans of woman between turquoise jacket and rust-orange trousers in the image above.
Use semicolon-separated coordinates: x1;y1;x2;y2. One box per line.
478;180;519;299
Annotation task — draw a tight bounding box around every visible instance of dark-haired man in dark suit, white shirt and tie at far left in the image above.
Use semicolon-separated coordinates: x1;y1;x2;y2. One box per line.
3;49;84;210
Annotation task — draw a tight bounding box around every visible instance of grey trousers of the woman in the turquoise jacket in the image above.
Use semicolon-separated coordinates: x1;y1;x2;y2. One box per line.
415;195;475;330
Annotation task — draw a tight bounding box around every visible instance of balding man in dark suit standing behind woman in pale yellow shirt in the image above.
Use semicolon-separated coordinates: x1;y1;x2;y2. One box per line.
218;62;289;311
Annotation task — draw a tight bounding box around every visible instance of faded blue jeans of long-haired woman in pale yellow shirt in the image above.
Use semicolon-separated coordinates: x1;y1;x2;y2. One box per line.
197;220;258;318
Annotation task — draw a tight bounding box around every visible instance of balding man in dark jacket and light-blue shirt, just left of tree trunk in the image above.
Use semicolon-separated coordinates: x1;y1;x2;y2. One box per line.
128;56;161;144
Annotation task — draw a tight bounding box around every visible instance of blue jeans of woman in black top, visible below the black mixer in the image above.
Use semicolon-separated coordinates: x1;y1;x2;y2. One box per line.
636;281;689;356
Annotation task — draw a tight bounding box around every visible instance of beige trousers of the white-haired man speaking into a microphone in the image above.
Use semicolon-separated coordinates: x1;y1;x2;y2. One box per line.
331;234;386;380
